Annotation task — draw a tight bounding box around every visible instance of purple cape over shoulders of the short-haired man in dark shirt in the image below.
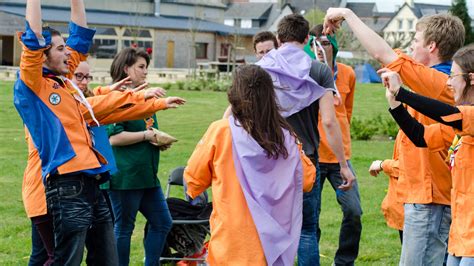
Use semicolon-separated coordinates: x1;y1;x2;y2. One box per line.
256;43;326;117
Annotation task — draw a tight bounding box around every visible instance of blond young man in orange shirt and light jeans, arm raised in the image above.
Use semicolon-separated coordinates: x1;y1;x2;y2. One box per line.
324;8;465;266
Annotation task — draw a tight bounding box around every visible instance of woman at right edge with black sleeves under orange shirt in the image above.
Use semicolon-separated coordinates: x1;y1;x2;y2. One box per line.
382;45;474;266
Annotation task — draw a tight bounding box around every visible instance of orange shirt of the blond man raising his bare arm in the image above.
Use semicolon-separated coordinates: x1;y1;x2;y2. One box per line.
386;51;454;205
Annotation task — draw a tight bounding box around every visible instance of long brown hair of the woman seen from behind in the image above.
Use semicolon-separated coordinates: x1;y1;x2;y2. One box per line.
227;65;296;159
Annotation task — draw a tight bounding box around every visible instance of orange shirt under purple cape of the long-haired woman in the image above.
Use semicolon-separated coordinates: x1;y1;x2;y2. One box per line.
184;119;316;265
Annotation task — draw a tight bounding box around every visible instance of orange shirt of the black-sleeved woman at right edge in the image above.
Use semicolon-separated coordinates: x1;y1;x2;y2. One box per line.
442;106;474;257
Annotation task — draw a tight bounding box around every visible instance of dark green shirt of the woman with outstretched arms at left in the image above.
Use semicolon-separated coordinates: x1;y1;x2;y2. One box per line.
107;115;160;190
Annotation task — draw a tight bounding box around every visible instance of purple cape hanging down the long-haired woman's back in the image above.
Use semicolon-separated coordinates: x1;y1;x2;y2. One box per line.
229;116;303;265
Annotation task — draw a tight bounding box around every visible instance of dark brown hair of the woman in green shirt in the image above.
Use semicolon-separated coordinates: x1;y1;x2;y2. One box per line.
110;48;150;82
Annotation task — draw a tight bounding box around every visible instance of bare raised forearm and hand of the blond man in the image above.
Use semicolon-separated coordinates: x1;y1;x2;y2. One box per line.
324;8;397;65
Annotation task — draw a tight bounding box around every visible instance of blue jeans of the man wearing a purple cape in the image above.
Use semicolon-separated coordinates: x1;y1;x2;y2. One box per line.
298;157;320;266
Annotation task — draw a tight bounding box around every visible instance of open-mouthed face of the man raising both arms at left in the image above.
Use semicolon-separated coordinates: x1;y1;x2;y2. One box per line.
44;35;71;75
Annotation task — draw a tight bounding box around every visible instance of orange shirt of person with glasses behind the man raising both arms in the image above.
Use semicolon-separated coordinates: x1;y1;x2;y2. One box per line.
22;87;166;218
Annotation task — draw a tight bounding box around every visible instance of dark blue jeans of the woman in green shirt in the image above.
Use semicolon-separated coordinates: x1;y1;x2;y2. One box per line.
109;187;172;265
